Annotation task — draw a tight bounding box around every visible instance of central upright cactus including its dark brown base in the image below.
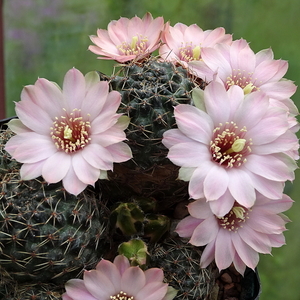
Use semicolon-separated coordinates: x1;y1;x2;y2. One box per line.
99;57;202;209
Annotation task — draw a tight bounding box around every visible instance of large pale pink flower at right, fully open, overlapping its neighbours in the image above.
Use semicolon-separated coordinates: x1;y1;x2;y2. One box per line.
162;82;298;215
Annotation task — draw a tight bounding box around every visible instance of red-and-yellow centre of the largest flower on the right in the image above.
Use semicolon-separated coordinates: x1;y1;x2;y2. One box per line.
210;122;252;168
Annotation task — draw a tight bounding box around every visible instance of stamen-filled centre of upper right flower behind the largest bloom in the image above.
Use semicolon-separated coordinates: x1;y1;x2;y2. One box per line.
225;69;259;95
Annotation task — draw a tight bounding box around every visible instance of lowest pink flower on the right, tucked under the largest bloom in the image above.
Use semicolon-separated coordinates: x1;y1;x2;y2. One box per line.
175;194;293;274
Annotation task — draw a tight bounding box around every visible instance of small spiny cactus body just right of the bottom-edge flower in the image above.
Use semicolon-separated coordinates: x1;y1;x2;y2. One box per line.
150;238;218;300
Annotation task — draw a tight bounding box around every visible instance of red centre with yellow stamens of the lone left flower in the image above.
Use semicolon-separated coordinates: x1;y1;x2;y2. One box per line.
50;108;91;153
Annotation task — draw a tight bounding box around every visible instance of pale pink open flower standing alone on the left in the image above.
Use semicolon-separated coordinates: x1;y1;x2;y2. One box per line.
5;69;132;195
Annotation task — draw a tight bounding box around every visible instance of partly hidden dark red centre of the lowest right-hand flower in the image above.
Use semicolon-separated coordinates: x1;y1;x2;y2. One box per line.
217;203;251;232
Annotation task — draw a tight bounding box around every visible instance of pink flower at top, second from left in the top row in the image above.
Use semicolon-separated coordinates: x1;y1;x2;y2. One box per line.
159;22;232;67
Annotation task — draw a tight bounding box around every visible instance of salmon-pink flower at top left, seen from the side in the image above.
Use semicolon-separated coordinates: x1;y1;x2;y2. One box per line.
89;13;164;63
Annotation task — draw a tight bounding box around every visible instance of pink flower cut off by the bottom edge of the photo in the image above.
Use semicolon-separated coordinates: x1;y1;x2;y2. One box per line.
62;255;176;300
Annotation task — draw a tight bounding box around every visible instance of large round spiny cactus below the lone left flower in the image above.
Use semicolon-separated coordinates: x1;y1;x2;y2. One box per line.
0;129;108;283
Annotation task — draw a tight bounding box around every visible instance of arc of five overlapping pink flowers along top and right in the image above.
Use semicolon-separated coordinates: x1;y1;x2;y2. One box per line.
89;14;299;274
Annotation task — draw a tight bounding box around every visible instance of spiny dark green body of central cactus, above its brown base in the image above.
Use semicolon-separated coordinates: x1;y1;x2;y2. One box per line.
105;59;197;170
